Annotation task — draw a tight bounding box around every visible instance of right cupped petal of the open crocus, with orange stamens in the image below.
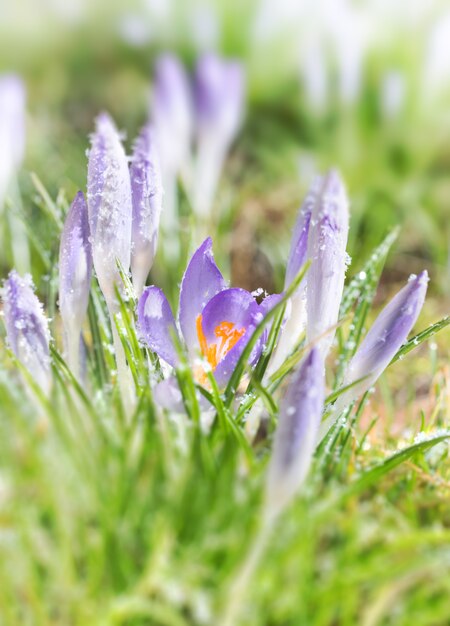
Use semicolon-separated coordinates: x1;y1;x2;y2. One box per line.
199;289;264;387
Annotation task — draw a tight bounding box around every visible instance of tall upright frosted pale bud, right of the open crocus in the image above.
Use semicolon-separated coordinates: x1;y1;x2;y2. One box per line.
306;171;349;356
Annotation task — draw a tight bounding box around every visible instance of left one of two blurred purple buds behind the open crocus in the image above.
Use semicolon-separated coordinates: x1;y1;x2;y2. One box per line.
152;54;192;175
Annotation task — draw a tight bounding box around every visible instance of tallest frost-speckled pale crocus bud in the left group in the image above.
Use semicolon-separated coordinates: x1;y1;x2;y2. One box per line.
87;113;132;307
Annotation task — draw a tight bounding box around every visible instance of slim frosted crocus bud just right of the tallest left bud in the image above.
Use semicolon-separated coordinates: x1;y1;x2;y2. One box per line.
130;125;162;296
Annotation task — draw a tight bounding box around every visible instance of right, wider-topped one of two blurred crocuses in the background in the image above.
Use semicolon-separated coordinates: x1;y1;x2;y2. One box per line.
192;54;244;217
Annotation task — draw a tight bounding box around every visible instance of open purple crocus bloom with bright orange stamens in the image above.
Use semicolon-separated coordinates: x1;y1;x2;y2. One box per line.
138;238;280;388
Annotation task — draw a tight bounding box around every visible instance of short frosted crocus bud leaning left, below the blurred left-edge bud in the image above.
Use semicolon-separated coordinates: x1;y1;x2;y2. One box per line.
2;270;50;391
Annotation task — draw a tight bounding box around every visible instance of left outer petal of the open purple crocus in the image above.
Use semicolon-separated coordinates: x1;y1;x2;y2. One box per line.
137;286;178;367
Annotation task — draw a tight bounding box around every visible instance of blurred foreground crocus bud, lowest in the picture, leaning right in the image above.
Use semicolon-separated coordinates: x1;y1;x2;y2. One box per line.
266;348;325;517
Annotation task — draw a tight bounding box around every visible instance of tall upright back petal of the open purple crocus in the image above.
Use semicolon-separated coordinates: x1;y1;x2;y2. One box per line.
178;237;227;354
